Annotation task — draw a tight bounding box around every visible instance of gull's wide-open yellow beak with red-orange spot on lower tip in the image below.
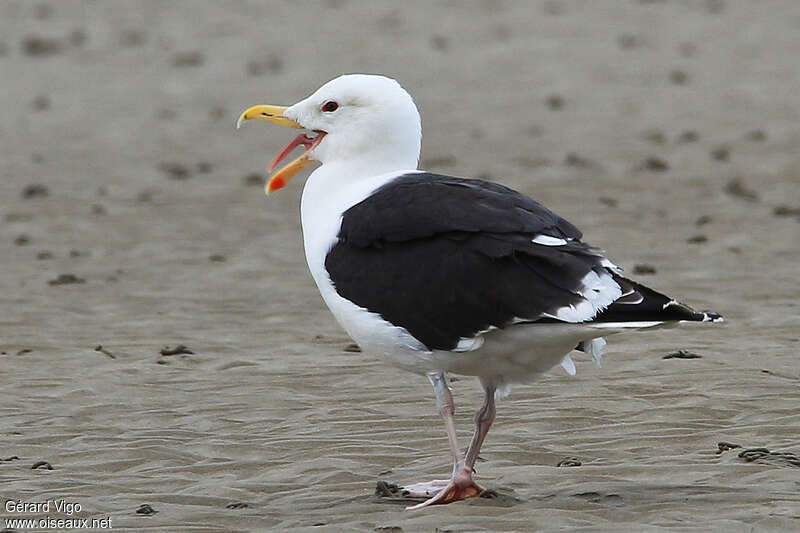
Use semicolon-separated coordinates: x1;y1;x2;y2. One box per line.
236;105;325;194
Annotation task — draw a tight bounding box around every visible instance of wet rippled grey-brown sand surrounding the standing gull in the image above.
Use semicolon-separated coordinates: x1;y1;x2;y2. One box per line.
0;0;800;532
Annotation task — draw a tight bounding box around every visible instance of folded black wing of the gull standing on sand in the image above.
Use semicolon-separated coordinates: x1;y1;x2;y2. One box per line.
325;173;619;350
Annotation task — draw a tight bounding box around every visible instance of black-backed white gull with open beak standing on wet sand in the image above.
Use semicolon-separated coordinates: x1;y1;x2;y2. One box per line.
237;74;722;509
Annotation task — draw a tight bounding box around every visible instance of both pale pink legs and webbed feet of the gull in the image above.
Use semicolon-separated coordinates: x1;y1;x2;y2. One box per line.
406;374;495;510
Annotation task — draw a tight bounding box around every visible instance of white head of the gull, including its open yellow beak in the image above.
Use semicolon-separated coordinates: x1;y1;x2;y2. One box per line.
237;74;422;193
